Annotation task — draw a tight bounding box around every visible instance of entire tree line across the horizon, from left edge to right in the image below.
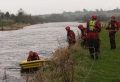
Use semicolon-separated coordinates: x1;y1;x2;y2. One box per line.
0;8;120;26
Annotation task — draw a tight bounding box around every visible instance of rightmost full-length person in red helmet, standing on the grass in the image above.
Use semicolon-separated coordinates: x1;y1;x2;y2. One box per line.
106;15;119;50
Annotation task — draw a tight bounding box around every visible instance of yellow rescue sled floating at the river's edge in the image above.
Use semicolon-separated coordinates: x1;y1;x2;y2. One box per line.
20;58;48;69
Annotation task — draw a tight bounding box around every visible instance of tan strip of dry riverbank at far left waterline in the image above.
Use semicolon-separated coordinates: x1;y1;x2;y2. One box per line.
0;23;30;31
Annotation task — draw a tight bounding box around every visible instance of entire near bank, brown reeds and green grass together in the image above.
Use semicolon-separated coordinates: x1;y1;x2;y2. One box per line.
23;28;120;82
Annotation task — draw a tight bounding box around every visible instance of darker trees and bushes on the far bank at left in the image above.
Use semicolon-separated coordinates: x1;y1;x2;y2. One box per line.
0;8;44;26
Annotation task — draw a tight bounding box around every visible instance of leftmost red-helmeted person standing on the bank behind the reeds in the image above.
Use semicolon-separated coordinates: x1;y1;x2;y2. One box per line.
65;26;76;47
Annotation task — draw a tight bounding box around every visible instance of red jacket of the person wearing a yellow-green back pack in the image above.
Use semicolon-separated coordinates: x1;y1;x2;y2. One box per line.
87;20;101;39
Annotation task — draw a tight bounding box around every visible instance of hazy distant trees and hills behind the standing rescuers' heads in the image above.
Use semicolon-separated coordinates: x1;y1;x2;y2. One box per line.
39;8;120;22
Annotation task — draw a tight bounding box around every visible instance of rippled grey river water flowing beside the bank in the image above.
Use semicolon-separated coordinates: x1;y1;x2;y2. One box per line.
0;22;85;82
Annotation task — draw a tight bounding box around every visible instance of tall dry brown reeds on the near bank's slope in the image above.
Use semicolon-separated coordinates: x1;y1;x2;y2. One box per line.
23;34;86;82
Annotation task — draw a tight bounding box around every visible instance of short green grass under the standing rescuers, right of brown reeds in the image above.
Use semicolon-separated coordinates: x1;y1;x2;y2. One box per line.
72;28;120;82
